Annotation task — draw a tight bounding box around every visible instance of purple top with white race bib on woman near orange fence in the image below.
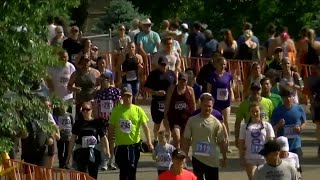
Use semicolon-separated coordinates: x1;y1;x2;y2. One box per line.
209;72;233;112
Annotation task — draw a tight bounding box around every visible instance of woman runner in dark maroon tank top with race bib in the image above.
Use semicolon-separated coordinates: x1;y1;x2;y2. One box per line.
164;73;196;148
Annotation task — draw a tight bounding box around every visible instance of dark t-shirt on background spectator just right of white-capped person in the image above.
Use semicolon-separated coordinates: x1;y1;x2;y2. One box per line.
186;32;206;57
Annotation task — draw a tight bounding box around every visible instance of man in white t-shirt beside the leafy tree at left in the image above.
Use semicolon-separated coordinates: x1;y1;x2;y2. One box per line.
47;51;76;101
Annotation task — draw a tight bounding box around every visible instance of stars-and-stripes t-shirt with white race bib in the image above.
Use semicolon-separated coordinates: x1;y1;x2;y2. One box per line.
94;87;121;120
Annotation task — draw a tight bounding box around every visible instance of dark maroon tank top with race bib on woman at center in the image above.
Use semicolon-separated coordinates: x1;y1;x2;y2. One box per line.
168;86;194;122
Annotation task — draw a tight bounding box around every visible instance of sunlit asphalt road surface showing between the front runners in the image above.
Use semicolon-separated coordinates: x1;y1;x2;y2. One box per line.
98;105;320;180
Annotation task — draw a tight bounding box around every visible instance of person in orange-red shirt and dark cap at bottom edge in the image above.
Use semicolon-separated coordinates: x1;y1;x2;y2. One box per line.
158;149;197;180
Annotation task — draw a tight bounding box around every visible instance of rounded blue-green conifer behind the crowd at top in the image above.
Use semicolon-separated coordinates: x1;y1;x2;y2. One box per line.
97;0;146;32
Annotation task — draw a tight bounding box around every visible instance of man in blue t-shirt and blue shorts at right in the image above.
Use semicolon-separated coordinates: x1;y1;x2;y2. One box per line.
270;91;306;161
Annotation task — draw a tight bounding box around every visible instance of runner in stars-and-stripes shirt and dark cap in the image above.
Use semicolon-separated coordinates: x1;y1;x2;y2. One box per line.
94;73;121;170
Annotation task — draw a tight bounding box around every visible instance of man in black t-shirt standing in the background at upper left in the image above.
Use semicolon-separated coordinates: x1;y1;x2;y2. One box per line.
62;26;82;64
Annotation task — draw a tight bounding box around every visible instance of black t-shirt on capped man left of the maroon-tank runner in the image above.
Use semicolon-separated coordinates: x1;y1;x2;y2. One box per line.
144;69;173;101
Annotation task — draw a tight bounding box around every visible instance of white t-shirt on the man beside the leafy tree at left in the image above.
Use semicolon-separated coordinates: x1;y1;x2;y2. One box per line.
48;62;76;100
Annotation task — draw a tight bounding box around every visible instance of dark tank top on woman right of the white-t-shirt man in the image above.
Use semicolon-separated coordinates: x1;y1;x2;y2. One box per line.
75;69;96;104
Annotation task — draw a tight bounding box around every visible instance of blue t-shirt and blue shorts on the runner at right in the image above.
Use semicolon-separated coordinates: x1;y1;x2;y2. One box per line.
270;104;306;151
